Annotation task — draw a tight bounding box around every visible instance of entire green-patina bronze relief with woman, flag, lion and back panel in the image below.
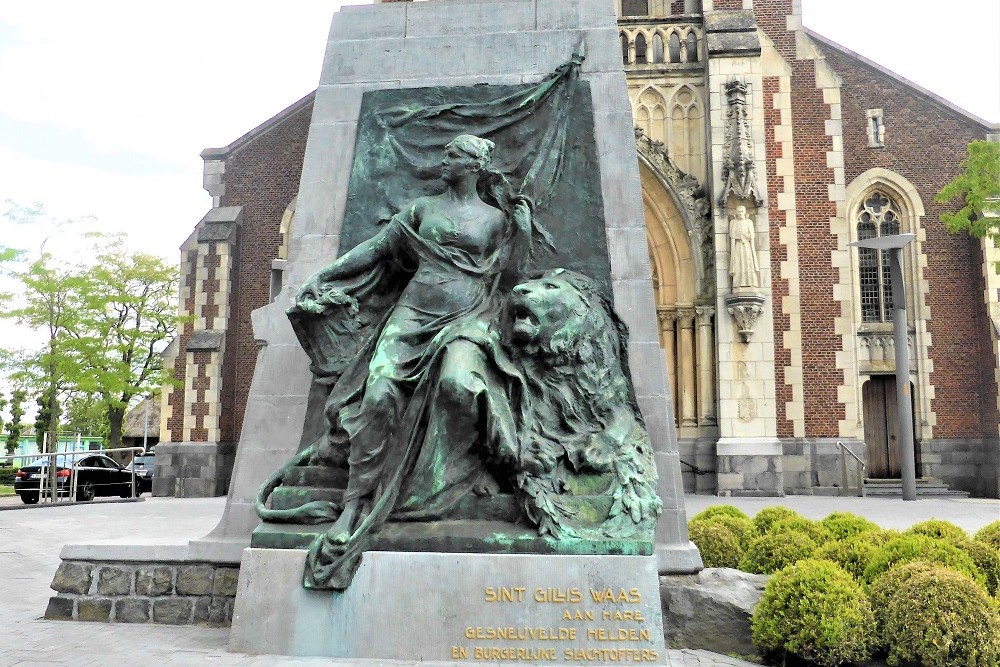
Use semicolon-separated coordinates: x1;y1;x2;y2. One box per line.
253;57;661;589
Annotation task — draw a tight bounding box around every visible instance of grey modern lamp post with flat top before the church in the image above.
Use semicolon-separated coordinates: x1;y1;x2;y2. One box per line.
849;234;917;500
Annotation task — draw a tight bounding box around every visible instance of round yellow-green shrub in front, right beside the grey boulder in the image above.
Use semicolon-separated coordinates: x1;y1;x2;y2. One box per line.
751;559;875;667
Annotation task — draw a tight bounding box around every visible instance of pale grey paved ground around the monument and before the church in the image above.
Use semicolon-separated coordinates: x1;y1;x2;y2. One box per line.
0;496;1000;667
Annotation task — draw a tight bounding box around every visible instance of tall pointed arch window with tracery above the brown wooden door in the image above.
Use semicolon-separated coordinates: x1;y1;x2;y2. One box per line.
857;190;900;322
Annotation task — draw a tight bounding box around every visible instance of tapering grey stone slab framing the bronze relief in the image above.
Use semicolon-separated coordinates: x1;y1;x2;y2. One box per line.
191;0;700;572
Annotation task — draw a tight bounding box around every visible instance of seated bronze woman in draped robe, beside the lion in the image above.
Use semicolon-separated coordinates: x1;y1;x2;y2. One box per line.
293;135;531;585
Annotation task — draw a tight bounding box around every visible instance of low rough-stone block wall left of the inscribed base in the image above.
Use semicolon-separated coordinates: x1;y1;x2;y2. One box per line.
45;560;240;626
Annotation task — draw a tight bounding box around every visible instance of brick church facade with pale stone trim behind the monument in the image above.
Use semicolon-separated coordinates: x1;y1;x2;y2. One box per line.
154;0;1000;497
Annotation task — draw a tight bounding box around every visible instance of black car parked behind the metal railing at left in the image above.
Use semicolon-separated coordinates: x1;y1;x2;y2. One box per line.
14;452;140;505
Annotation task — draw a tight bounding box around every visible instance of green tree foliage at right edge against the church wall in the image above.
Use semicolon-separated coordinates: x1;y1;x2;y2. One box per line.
935;141;1000;246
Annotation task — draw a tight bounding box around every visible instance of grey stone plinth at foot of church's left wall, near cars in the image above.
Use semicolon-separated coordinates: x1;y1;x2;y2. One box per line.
153;442;236;498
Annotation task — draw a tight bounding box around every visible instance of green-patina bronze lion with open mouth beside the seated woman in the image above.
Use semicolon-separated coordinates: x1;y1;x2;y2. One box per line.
505;269;660;539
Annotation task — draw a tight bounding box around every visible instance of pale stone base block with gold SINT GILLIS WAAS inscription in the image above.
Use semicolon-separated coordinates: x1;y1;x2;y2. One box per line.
229;549;666;665
